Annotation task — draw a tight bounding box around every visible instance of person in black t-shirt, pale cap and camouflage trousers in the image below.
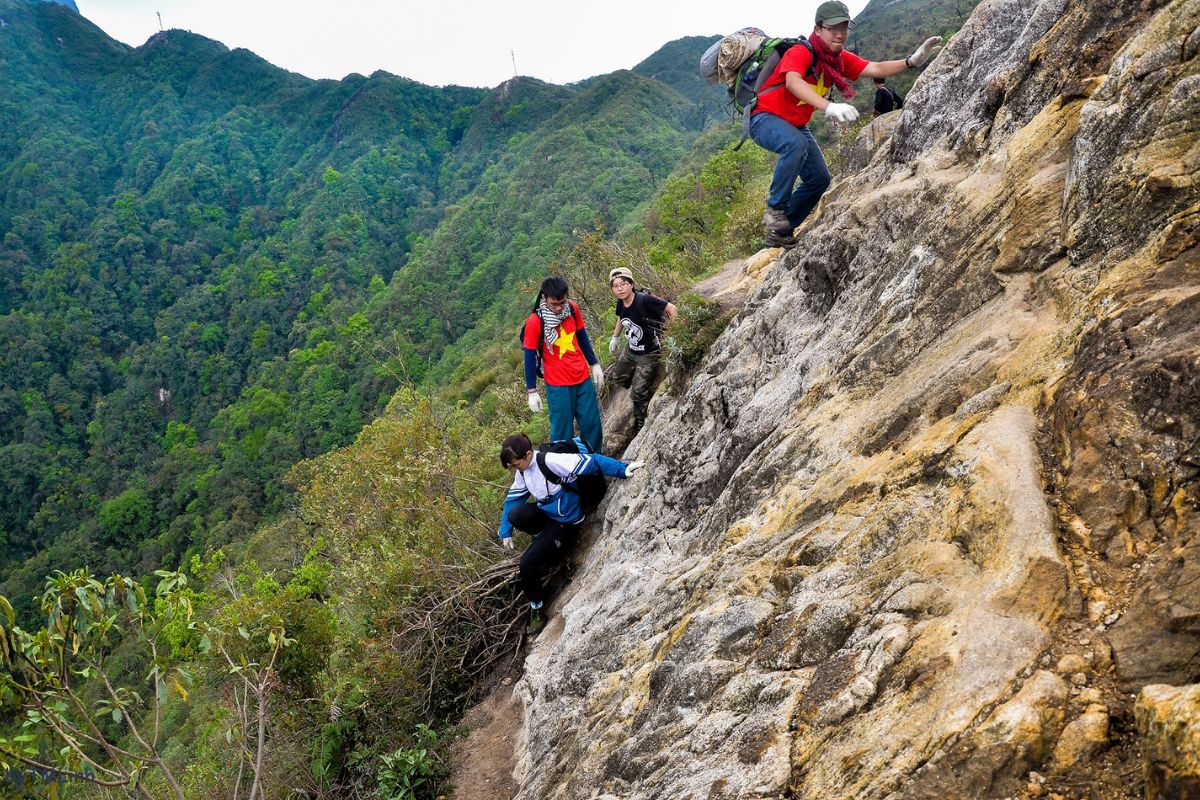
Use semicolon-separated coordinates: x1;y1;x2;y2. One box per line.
608;266;676;439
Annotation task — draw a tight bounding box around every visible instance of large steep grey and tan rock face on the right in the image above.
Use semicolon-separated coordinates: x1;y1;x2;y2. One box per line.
515;0;1200;800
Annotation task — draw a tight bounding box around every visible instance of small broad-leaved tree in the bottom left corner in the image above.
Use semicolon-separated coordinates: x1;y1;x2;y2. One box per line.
0;569;192;800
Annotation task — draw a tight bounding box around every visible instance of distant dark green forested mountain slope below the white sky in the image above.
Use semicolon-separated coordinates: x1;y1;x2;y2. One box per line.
0;0;704;618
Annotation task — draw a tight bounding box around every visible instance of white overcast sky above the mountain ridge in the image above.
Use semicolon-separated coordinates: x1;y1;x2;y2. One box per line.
76;0;866;86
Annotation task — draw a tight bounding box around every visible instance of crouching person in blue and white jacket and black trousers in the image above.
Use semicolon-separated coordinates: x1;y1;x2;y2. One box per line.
499;433;643;633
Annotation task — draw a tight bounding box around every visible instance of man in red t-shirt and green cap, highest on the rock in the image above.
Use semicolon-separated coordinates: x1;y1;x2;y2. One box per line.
750;0;942;247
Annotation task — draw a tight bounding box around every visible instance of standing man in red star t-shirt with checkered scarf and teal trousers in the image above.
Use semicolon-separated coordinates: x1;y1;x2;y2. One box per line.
522;276;604;452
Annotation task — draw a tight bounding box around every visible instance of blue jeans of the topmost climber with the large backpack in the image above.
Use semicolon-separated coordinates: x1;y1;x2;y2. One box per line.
750;112;830;228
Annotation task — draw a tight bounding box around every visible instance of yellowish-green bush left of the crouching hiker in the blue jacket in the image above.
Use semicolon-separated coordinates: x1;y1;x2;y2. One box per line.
289;386;524;760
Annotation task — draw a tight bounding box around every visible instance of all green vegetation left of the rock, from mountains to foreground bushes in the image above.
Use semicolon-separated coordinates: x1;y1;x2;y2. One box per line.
0;0;974;800
